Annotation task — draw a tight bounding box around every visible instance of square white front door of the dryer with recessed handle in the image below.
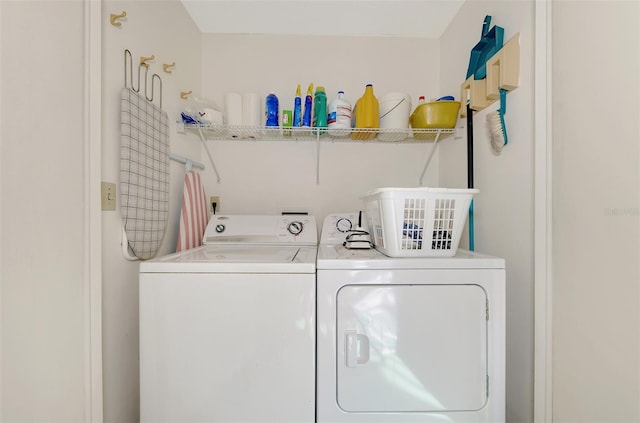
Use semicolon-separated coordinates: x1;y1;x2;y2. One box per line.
336;285;488;412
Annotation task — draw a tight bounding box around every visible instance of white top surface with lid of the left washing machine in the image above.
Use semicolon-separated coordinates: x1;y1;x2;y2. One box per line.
140;245;317;273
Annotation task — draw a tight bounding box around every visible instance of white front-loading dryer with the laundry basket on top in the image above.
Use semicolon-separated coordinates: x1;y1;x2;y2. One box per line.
316;213;505;423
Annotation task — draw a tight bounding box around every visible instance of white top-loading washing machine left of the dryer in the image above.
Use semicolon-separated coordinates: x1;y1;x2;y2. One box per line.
140;215;317;423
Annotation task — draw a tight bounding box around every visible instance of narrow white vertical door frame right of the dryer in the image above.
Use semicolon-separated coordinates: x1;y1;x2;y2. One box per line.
533;0;553;423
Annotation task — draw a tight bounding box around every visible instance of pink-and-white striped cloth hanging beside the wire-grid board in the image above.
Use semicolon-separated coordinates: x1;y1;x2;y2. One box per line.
176;170;209;251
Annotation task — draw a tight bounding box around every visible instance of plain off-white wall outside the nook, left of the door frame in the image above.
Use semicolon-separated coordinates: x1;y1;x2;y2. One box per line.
0;1;88;422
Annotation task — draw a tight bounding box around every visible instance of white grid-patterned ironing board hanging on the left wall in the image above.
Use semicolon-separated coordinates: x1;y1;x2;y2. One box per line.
120;88;169;260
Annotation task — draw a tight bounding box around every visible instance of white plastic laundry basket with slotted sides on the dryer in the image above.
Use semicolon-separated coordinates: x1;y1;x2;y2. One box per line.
363;188;479;257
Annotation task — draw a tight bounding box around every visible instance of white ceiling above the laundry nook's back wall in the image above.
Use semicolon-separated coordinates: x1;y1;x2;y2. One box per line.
182;0;465;38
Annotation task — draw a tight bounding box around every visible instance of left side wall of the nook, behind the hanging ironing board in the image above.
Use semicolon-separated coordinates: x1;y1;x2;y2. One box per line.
102;0;202;422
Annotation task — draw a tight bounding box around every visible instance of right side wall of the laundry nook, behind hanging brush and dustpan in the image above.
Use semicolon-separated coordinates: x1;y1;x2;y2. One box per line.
439;0;535;423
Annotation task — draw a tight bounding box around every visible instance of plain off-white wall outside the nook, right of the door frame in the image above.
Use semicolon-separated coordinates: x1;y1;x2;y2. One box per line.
552;1;640;422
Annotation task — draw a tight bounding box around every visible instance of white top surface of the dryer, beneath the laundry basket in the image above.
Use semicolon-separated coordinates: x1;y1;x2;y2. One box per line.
317;244;505;269
